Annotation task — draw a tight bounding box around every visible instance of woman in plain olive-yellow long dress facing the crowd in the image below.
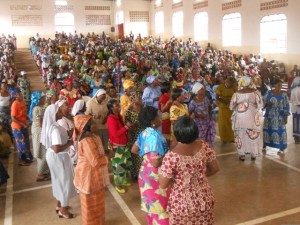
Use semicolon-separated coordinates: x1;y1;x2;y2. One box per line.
215;77;237;144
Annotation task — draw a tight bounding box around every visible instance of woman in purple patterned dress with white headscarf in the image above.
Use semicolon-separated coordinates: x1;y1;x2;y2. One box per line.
189;82;216;148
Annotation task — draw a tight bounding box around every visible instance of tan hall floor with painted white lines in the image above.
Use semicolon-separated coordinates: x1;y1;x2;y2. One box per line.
0;114;300;225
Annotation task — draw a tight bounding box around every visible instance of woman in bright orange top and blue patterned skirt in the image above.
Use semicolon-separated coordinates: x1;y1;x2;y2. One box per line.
11;92;33;166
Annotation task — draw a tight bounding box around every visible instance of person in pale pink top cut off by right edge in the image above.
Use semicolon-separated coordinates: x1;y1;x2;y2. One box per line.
291;72;300;144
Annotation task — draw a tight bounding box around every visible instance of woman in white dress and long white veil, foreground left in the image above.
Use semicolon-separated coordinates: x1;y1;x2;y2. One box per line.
41;104;76;219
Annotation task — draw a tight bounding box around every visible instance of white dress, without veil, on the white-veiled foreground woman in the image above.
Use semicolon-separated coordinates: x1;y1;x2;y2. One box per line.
46;123;76;207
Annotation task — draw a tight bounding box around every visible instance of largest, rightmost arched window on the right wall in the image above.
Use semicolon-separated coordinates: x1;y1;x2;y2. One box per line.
260;14;287;53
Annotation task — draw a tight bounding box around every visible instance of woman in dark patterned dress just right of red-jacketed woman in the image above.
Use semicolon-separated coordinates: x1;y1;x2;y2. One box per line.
125;93;143;181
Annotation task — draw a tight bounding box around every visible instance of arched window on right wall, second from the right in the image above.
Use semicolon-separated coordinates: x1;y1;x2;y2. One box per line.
222;13;242;46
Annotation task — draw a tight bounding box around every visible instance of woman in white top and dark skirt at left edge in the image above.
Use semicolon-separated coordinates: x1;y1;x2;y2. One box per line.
0;81;13;138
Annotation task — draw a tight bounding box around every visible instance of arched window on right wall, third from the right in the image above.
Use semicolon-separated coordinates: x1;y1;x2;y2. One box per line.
194;12;208;41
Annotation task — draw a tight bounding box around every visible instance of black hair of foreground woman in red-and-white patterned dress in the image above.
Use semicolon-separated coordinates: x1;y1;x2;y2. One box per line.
174;115;199;144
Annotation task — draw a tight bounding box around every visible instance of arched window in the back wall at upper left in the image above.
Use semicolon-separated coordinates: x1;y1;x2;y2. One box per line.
55;12;75;34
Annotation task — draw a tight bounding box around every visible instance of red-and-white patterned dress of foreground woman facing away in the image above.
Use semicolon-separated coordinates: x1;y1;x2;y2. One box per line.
160;141;216;225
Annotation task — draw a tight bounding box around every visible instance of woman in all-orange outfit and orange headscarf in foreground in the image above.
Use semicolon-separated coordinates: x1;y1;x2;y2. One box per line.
73;115;109;225
